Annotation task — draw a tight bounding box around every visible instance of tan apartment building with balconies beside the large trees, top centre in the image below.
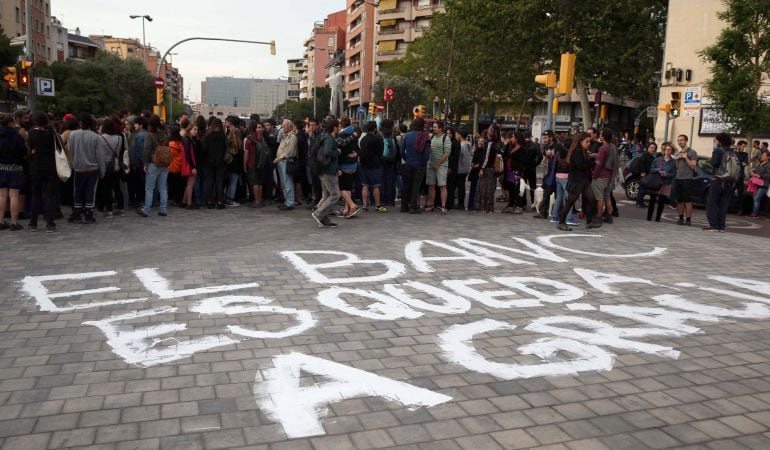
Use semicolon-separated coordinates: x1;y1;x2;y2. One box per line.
374;0;444;74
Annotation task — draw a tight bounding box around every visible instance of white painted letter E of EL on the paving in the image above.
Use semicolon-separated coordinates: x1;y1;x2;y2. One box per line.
21;270;147;312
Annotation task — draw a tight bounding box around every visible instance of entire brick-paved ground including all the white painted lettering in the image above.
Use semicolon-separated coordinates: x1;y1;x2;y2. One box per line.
0;208;770;450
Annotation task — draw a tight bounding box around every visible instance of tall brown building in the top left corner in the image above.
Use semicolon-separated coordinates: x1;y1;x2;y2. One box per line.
0;0;56;62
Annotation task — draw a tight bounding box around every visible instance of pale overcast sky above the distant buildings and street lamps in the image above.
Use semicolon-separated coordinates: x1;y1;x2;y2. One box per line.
51;0;345;101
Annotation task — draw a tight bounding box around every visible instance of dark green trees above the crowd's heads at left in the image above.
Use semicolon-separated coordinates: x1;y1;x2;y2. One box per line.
36;52;155;115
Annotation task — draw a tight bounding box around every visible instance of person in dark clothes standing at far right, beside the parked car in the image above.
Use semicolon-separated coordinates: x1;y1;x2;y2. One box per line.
703;133;740;233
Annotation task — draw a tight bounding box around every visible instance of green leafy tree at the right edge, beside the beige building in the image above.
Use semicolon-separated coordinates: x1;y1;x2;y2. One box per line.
700;0;770;138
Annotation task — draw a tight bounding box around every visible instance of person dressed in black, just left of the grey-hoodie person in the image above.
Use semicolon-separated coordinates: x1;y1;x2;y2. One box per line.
29;112;58;233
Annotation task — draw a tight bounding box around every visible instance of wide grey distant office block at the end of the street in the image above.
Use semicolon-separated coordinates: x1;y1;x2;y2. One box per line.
200;77;289;119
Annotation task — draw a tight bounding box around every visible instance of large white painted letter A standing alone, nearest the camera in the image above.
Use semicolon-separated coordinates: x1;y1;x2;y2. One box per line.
254;353;452;439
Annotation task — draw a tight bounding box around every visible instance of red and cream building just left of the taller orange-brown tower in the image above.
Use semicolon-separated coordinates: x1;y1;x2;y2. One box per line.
300;10;347;99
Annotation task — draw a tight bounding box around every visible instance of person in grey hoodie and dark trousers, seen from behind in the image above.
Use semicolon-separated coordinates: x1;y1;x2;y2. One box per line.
67;113;105;224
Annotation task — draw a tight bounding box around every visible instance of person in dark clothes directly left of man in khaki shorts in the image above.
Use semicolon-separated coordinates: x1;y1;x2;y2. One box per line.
401;117;431;214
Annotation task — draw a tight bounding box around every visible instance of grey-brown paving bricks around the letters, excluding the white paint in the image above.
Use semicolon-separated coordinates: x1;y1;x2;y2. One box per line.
0;208;770;450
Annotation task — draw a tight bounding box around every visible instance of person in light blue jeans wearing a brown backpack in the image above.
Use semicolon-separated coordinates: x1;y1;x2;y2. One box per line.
136;114;168;217
